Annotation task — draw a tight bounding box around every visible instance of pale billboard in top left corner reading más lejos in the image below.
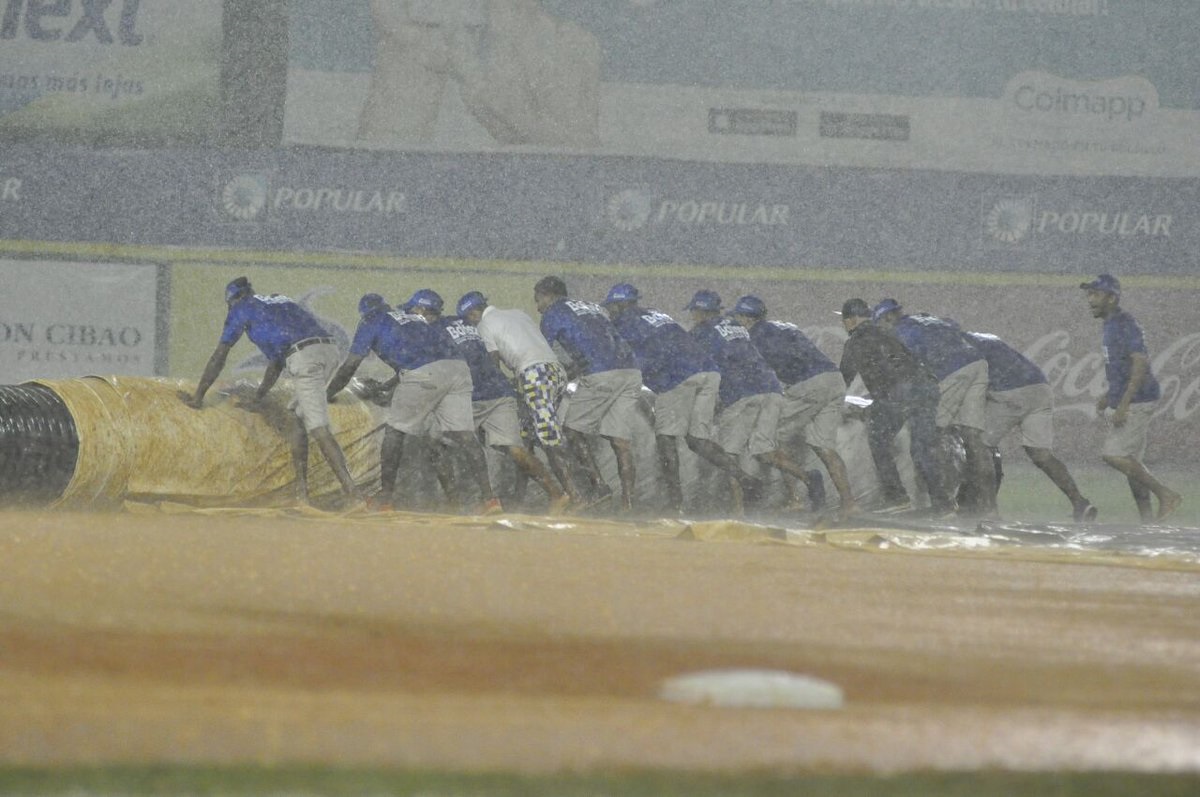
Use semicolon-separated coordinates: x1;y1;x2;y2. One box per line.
0;0;222;146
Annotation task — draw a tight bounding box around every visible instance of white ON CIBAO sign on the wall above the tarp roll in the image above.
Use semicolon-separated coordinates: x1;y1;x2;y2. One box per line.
0;259;160;384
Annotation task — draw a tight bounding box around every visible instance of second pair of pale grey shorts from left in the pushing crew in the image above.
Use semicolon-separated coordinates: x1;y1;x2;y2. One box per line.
384;360;475;435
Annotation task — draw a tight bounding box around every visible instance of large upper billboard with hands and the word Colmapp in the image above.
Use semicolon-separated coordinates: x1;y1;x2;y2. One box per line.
284;0;1200;176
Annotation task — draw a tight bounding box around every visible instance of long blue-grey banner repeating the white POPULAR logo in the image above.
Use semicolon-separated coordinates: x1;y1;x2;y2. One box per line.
0;148;1200;275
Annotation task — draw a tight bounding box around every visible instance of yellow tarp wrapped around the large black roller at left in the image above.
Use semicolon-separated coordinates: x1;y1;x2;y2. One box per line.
37;377;382;507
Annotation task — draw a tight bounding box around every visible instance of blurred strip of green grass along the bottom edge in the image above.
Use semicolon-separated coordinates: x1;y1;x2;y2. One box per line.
0;767;1200;797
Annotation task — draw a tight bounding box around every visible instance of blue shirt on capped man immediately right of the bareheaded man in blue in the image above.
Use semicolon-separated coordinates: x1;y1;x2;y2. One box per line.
612;307;716;392
